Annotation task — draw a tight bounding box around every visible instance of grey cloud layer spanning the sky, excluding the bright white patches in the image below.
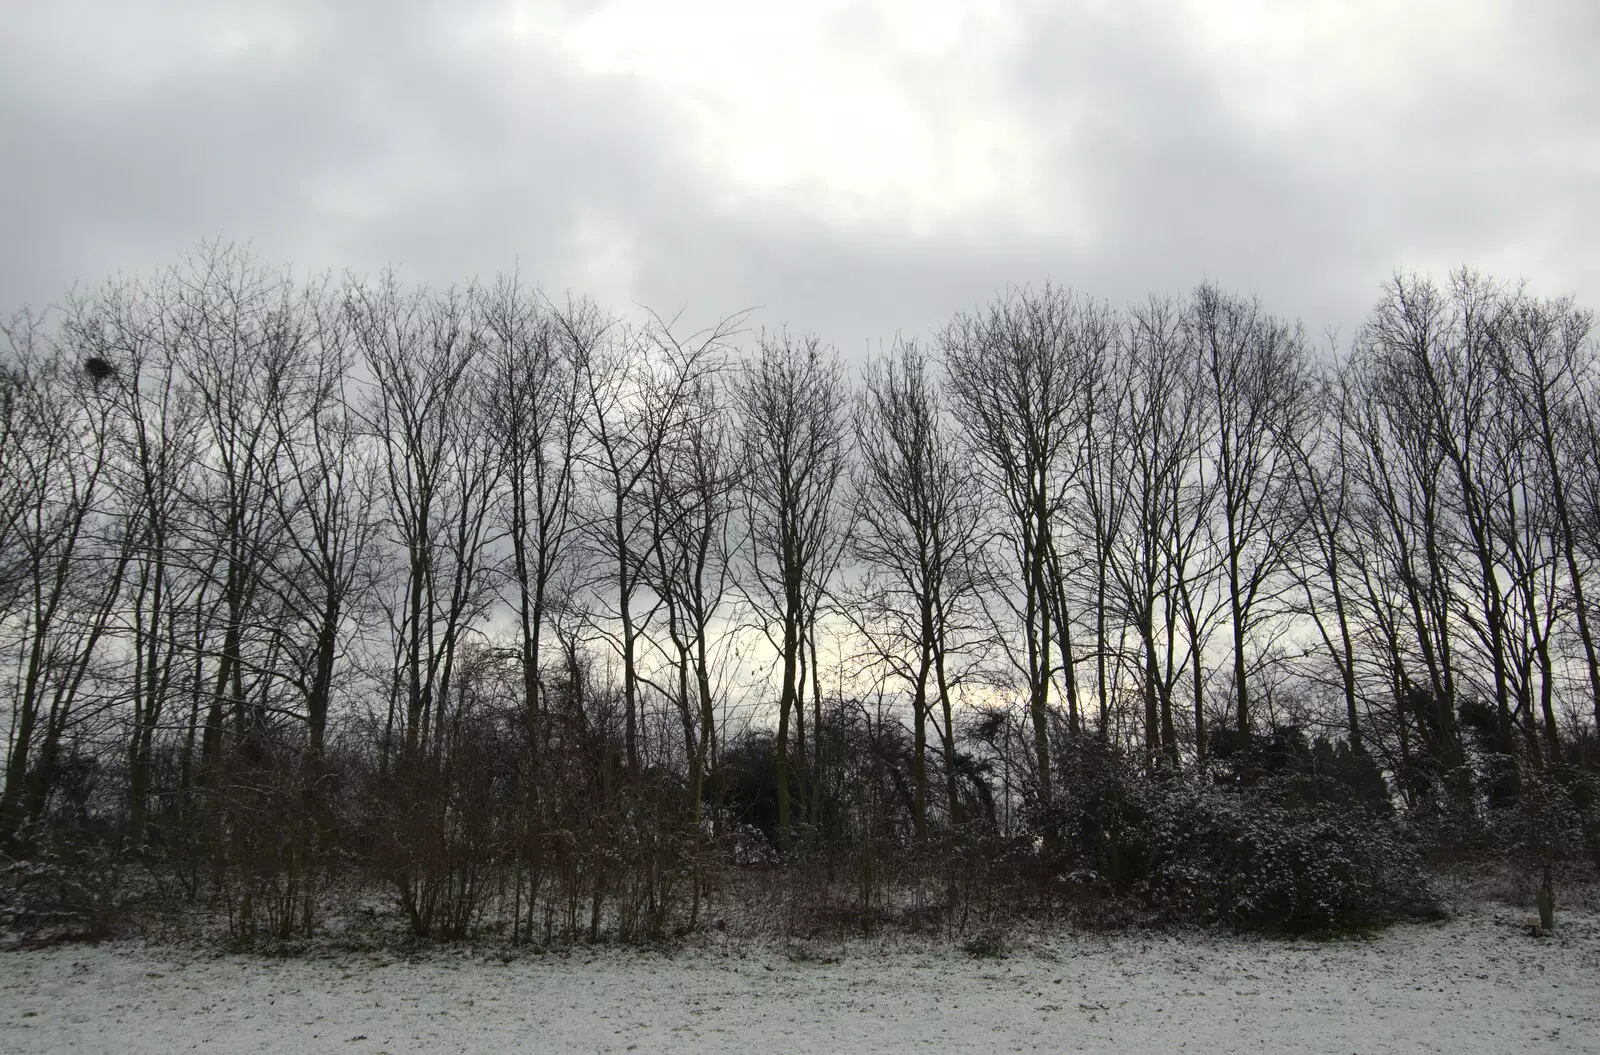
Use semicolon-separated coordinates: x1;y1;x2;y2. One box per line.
0;3;1600;352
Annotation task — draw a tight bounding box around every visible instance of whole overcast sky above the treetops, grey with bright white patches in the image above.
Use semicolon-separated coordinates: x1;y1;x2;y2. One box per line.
0;0;1600;354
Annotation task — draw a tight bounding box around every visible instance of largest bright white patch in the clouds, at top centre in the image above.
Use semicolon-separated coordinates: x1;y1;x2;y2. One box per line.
507;0;1070;234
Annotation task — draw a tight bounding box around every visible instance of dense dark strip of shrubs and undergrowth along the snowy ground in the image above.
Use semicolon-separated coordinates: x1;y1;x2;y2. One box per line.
0;730;1595;956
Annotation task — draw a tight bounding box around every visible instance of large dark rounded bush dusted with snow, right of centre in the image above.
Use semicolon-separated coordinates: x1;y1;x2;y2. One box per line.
1038;743;1430;927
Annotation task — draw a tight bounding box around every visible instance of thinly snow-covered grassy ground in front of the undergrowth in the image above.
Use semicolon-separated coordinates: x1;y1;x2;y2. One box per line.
0;909;1600;1055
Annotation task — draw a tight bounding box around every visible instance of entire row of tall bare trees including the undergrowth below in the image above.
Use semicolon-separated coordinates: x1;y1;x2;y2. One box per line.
0;245;1600;941
